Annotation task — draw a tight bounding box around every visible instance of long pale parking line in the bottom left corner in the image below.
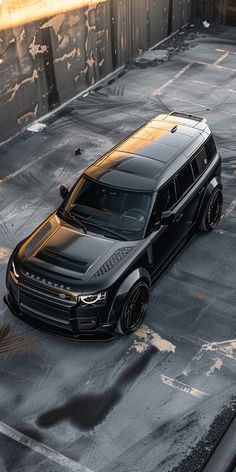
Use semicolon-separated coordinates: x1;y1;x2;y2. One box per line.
0;421;93;472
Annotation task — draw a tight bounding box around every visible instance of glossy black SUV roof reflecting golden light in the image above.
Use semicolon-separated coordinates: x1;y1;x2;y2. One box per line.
85;113;210;191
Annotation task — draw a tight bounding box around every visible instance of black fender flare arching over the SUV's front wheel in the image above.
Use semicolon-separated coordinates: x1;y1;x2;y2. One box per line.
107;267;151;323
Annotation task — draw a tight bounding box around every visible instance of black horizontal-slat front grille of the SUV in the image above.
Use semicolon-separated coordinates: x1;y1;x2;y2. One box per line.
19;284;74;326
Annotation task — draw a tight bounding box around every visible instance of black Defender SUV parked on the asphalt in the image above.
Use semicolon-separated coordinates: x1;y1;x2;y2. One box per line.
5;112;223;339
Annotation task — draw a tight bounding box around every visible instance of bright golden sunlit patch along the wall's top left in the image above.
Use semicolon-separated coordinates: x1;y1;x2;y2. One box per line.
0;0;107;30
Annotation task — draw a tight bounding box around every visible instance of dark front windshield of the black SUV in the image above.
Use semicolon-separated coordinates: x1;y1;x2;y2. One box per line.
62;177;151;240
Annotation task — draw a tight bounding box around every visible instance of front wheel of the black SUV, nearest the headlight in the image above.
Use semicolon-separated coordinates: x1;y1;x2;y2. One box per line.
116;281;149;334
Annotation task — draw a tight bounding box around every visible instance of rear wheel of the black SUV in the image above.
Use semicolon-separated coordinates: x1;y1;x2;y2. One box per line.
200;188;223;233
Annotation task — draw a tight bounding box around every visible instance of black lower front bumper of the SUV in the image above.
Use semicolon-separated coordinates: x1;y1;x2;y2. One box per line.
4;280;115;341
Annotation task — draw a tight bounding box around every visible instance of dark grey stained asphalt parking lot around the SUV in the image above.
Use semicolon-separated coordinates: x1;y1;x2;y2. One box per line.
0;23;236;472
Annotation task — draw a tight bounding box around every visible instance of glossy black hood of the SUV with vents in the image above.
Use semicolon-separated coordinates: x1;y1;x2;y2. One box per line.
20;216;135;286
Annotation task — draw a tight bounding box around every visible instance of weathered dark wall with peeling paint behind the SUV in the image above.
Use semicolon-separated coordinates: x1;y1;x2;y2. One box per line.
0;0;194;141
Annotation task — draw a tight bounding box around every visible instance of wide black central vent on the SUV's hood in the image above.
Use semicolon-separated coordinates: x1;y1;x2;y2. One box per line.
37;248;88;274
